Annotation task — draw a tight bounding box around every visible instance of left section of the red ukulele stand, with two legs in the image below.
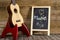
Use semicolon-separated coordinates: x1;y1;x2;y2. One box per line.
1;23;18;40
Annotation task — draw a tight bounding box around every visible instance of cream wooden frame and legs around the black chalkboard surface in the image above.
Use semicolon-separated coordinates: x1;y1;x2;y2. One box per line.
30;6;51;36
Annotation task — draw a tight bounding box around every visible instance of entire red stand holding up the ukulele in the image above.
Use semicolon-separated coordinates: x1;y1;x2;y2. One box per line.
1;23;30;40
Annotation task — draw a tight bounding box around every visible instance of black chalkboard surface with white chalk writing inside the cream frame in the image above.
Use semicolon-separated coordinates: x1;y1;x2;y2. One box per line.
33;8;48;29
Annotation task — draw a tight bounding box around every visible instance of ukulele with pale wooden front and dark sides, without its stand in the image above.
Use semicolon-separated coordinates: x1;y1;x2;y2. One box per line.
7;0;24;27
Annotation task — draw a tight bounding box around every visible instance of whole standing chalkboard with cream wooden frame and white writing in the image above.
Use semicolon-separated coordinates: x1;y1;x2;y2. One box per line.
31;6;50;35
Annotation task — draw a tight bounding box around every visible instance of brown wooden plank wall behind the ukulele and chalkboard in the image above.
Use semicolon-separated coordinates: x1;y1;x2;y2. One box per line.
0;0;60;34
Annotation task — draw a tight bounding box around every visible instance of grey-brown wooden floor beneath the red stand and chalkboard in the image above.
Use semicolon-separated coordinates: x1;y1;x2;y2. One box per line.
0;34;60;40
